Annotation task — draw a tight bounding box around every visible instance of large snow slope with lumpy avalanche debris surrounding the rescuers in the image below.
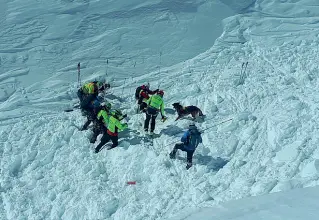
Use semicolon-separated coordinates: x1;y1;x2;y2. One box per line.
0;0;319;220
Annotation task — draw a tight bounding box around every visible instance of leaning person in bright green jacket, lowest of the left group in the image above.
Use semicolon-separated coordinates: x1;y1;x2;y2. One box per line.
95;110;127;153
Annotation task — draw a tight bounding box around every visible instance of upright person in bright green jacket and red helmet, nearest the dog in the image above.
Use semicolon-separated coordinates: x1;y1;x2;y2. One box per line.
144;90;166;134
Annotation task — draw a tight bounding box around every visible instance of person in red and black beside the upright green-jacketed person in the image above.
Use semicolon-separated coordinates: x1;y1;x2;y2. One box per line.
135;83;158;112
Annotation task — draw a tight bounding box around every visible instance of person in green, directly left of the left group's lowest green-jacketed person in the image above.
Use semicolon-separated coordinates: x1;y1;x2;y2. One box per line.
90;102;112;143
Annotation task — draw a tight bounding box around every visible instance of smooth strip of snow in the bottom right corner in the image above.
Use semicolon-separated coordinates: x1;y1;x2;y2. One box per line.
170;187;319;220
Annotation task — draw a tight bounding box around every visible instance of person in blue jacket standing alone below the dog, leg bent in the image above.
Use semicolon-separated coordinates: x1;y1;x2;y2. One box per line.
169;124;203;169
